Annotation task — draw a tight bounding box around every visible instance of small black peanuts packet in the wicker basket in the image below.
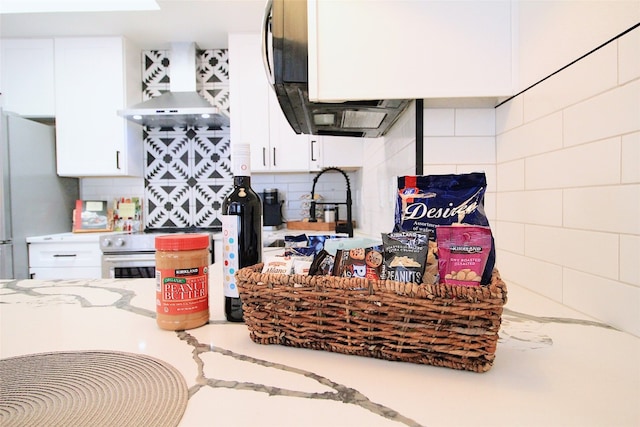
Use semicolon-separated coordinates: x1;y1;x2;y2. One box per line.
382;231;429;283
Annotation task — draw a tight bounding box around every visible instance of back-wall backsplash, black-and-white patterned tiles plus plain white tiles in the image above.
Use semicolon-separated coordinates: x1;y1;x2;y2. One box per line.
80;49;361;229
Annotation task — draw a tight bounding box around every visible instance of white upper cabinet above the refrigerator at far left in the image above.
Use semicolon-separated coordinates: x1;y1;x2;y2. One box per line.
0;39;55;118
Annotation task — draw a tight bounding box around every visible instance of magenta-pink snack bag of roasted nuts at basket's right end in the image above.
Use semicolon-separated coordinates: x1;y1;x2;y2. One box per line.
436;226;491;286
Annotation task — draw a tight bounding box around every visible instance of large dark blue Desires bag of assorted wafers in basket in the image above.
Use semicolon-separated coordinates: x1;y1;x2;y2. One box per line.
394;172;495;284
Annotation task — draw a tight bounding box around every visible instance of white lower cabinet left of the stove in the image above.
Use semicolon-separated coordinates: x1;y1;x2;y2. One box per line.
27;233;113;279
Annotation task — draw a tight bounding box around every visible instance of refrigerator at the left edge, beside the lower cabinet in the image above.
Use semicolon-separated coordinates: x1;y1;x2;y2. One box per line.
0;108;79;279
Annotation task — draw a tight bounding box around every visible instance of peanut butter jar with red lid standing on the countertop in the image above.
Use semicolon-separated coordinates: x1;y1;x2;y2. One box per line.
155;233;210;331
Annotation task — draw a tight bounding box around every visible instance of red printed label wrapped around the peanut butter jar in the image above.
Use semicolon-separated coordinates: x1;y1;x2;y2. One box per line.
156;267;209;315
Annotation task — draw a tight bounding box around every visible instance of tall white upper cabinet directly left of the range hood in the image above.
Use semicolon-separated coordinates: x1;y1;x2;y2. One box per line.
55;37;143;177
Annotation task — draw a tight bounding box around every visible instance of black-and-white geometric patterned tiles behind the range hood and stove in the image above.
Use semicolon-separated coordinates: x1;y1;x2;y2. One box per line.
142;49;233;229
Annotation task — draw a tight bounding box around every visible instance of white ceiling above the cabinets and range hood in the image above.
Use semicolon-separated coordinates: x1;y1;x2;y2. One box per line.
0;0;266;50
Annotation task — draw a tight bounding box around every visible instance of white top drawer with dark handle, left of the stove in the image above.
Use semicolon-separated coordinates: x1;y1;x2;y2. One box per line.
29;243;102;268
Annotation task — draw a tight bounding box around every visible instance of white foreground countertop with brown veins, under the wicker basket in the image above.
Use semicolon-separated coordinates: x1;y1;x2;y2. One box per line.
0;264;640;427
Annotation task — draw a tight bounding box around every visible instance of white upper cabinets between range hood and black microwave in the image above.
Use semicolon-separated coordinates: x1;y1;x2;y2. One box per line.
229;33;313;173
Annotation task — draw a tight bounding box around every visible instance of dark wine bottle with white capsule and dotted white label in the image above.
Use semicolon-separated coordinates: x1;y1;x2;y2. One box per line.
222;144;262;322
